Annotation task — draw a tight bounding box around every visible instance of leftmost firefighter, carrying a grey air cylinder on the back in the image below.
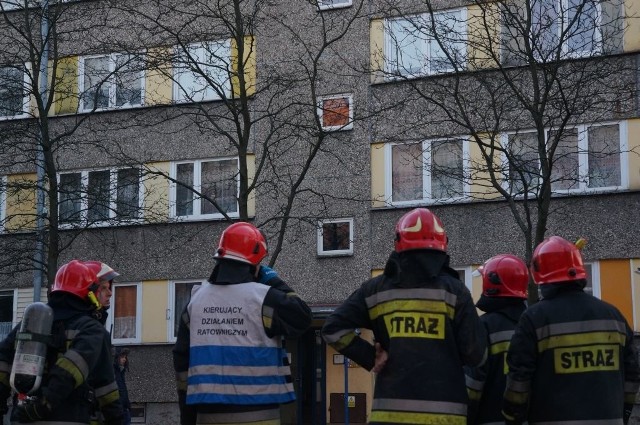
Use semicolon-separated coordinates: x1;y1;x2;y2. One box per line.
0;260;123;425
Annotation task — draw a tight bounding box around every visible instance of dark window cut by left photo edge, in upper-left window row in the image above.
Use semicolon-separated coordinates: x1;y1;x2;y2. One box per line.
0;67;29;119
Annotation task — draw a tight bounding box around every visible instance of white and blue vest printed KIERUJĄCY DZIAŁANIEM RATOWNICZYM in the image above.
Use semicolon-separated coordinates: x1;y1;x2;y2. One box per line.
186;282;295;404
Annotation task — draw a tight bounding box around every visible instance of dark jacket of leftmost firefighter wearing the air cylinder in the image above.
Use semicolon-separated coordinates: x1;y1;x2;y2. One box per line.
0;292;123;425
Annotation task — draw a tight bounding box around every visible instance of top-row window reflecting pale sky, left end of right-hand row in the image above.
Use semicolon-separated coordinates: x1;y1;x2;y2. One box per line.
384;9;466;79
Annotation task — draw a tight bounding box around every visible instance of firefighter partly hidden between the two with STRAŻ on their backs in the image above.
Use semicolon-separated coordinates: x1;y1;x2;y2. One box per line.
465;254;529;425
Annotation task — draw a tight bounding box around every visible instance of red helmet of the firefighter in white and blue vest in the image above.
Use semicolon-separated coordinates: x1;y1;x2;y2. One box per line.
214;222;267;266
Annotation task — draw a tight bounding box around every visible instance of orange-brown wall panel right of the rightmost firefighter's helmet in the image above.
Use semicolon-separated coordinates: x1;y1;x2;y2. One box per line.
600;260;633;323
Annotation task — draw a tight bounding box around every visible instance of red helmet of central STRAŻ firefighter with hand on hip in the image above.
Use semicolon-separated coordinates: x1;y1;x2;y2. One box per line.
395;208;447;252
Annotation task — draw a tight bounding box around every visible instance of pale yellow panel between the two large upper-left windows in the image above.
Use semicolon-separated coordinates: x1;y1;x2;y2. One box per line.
144;47;173;105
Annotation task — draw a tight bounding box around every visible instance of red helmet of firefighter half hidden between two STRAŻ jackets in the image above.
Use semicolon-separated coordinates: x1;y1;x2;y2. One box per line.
478;254;529;299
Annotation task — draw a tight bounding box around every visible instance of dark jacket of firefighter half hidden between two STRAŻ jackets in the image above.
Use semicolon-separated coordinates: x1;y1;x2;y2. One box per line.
465;296;527;425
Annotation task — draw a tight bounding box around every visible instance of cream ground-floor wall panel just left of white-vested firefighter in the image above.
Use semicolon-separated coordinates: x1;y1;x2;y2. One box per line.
142;280;169;343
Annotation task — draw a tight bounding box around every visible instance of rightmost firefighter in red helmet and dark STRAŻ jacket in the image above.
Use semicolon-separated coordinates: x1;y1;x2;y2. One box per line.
503;236;640;425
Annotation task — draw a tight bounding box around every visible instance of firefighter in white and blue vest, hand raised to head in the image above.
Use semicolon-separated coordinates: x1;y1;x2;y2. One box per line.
173;222;311;425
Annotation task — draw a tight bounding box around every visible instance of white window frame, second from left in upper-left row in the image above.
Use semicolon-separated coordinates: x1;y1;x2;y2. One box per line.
78;53;146;112
